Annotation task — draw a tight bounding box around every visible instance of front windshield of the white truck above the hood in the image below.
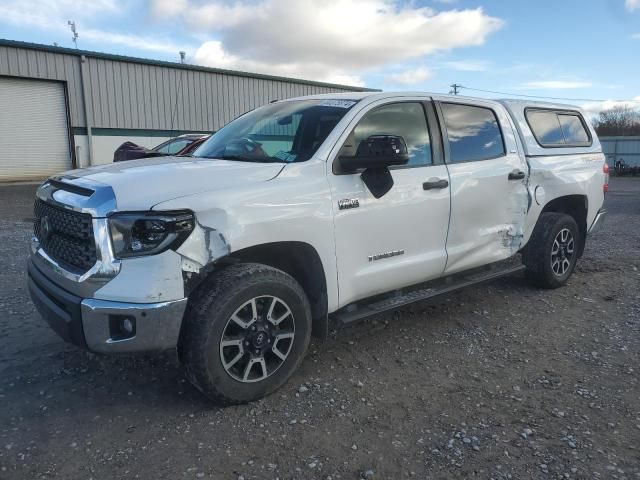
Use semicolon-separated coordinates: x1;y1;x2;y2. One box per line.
193;100;356;163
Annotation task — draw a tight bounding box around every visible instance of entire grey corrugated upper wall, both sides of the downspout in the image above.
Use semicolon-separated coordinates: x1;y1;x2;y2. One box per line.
0;41;368;131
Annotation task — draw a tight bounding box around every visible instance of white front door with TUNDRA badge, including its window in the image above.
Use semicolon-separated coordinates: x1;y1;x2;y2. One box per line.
329;99;449;306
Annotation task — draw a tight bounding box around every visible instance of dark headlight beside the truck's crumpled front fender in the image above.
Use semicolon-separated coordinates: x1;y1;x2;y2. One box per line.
109;211;194;258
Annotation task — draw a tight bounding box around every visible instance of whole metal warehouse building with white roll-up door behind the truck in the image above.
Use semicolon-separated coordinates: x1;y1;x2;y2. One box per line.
0;40;372;181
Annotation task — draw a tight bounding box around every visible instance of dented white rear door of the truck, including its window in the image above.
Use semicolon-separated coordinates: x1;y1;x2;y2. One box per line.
437;99;528;274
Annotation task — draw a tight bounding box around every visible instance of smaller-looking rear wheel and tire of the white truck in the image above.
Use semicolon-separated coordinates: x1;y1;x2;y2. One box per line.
524;212;582;288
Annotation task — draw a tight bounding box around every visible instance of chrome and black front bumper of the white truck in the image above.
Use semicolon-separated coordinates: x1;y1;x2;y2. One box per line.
28;260;187;353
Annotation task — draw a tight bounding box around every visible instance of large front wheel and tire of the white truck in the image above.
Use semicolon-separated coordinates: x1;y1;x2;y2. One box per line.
180;263;311;405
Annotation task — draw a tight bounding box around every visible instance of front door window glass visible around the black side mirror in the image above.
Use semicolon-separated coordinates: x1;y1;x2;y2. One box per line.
343;103;433;165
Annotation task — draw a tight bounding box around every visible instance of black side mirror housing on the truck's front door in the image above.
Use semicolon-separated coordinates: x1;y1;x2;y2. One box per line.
340;135;409;172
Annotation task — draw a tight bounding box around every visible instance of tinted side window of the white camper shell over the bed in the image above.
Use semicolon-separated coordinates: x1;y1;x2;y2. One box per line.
525;109;591;147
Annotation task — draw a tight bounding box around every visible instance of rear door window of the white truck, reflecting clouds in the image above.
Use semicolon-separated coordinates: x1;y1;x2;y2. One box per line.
441;103;505;162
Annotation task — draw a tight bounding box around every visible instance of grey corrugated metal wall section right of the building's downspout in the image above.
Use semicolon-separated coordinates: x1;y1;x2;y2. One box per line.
88;58;350;131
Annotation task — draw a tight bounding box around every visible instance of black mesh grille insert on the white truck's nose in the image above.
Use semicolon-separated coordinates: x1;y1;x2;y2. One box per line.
33;199;96;273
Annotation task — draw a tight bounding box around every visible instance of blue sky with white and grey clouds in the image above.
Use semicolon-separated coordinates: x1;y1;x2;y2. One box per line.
0;0;640;114
